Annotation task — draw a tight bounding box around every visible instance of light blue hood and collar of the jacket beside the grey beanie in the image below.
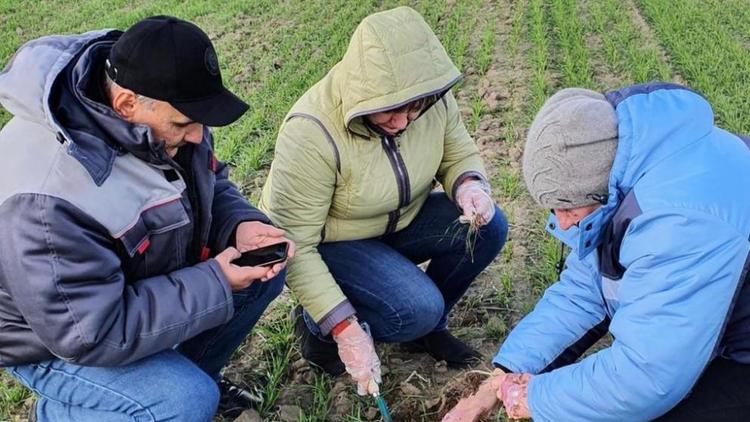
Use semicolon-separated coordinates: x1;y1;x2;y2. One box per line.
547;82;714;258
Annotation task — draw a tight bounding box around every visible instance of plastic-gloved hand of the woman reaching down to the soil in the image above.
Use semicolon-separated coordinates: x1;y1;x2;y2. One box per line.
333;320;381;396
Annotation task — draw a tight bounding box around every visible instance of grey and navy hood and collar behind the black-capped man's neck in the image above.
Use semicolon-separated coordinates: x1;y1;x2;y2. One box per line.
0;30;173;185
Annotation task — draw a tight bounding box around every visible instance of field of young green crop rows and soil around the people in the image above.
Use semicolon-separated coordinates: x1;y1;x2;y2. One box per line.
0;0;750;421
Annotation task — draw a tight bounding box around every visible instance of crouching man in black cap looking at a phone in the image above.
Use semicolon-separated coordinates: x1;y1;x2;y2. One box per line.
0;16;294;421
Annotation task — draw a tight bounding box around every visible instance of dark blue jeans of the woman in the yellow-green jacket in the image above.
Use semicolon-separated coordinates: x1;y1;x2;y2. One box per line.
304;192;508;343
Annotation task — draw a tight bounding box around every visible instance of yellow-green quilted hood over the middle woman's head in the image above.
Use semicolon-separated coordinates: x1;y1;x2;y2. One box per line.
332;6;461;128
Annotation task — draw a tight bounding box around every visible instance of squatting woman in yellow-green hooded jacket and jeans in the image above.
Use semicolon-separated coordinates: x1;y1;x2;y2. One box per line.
260;7;507;393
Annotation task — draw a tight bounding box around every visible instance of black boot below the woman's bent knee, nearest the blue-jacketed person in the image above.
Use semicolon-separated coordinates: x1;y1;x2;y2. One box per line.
404;330;482;368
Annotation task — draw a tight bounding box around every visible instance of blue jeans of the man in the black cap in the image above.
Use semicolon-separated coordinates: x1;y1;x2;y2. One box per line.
6;272;285;422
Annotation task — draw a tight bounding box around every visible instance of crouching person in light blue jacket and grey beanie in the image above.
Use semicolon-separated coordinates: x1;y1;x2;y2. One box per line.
444;83;750;421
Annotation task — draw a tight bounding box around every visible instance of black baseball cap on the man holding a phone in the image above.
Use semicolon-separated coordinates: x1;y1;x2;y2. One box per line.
106;16;248;126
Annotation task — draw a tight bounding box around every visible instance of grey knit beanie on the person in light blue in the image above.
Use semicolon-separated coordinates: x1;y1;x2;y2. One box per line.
523;88;617;209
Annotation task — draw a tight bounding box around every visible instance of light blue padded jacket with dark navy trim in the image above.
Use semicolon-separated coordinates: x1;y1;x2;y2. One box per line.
494;84;750;422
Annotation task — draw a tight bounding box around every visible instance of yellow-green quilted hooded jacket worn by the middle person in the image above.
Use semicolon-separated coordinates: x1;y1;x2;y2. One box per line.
260;7;486;334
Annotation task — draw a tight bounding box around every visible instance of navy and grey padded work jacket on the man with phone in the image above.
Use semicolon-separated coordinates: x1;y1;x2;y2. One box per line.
0;31;268;366
